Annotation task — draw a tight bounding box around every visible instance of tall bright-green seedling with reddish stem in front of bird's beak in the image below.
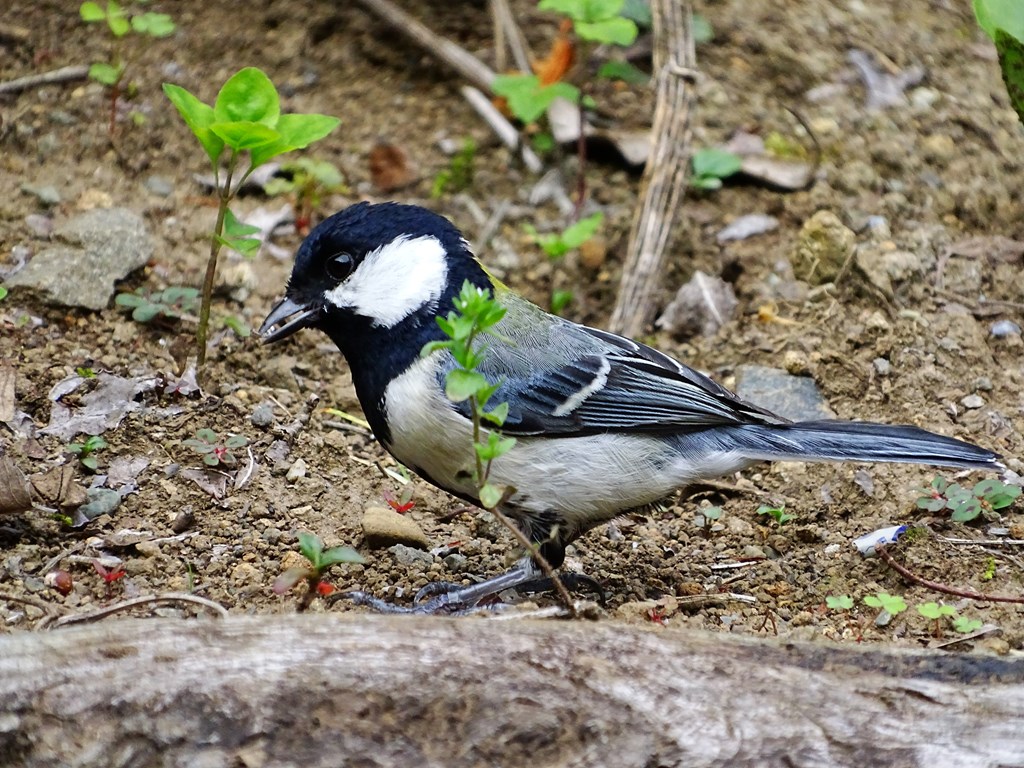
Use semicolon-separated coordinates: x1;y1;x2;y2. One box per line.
164;67;341;368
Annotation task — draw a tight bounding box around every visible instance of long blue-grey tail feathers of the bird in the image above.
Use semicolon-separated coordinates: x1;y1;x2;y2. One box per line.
732;421;1005;472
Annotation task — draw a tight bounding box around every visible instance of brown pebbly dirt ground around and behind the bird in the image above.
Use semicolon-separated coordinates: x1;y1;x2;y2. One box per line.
0;0;1024;653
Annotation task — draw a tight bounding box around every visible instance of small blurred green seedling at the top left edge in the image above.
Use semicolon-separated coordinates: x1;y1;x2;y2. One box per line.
78;0;176;136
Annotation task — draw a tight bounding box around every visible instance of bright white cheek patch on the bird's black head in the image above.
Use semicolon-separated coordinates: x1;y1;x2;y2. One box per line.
324;234;447;328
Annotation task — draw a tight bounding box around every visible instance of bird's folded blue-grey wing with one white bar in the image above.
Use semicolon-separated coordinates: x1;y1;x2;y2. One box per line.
461;296;786;436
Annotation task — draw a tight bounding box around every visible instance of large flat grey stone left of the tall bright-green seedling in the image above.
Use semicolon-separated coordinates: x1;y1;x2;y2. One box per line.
6;208;154;309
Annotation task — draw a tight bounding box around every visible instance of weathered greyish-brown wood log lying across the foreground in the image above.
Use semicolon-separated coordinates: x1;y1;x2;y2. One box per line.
0;614;1024;768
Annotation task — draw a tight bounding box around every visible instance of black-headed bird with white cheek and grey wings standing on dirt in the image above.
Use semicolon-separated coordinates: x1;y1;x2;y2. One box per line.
259;202;1004;612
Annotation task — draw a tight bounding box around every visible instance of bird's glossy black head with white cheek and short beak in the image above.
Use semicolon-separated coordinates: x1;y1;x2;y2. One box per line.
259;203;489;343
